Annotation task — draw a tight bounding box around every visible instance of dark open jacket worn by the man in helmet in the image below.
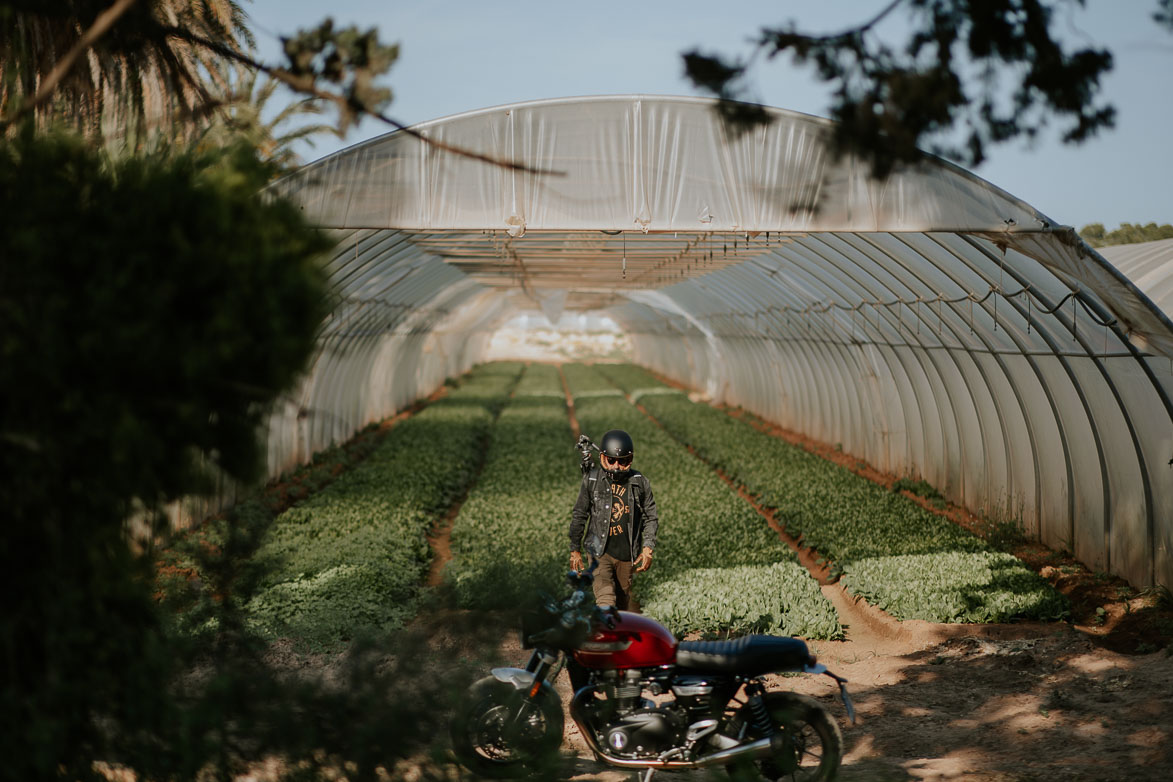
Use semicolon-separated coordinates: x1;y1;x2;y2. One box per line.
570;467;659;562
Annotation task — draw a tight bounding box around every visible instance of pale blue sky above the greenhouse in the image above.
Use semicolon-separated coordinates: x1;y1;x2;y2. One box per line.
243;0;1173;230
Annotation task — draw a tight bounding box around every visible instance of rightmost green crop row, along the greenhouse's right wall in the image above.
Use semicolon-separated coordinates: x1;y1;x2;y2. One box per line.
601;365;1065;621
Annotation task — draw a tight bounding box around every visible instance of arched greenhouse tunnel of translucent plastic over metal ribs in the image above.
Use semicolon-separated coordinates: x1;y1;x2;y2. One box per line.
240;95;1173;586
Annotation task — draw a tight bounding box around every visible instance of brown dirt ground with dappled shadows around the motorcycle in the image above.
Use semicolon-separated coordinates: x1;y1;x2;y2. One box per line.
469;574;1173;782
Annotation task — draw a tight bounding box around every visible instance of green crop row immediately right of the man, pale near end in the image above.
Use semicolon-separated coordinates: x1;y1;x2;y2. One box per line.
563;365;842;638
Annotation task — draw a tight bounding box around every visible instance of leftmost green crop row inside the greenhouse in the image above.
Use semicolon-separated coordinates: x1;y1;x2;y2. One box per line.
248;363;523;646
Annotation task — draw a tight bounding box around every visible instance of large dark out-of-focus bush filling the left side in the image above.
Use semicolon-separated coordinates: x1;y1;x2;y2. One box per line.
0;132;335;780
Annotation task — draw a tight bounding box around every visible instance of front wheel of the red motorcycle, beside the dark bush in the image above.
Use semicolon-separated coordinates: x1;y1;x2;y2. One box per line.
450;676;563;778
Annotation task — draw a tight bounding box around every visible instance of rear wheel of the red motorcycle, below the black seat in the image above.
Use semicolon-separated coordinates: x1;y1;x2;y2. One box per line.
728;693;843;782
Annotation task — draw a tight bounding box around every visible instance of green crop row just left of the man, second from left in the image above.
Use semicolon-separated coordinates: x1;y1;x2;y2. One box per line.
445;363;579;608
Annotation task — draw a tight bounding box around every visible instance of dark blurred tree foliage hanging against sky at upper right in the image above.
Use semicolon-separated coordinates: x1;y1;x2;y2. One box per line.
684;0;1173;177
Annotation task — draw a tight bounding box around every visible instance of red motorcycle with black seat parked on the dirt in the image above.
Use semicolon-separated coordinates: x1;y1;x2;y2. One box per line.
450;563;855;782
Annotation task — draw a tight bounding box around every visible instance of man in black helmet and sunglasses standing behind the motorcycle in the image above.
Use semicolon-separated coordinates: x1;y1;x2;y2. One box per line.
570;429;659;610
